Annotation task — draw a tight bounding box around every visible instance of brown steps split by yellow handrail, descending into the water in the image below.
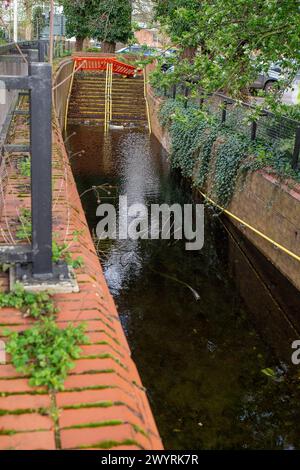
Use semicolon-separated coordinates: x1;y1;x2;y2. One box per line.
68;72;148;128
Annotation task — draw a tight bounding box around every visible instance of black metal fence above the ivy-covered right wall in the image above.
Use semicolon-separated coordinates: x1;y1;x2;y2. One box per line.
163;85;300;170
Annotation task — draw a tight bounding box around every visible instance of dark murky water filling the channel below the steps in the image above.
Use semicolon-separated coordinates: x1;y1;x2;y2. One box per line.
68;126;300;450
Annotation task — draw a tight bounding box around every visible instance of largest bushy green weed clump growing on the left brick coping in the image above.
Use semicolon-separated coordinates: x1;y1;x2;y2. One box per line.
7;317;87;390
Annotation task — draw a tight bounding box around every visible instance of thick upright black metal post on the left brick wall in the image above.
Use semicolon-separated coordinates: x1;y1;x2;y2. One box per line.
29;63;53;279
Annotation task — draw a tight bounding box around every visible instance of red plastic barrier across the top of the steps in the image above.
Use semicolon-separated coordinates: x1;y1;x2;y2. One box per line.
74;57;137;77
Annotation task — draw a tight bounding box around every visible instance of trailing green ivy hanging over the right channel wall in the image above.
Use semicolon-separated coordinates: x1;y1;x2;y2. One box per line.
159;100;300;207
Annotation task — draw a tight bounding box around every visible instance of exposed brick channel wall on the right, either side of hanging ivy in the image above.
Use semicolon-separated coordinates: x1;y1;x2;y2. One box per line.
147;85;300;290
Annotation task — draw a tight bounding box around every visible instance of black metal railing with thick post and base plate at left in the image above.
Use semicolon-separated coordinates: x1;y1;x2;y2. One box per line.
0;43;68;282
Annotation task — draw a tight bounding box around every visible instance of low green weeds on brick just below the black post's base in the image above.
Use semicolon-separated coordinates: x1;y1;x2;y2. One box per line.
0;283;56;318
